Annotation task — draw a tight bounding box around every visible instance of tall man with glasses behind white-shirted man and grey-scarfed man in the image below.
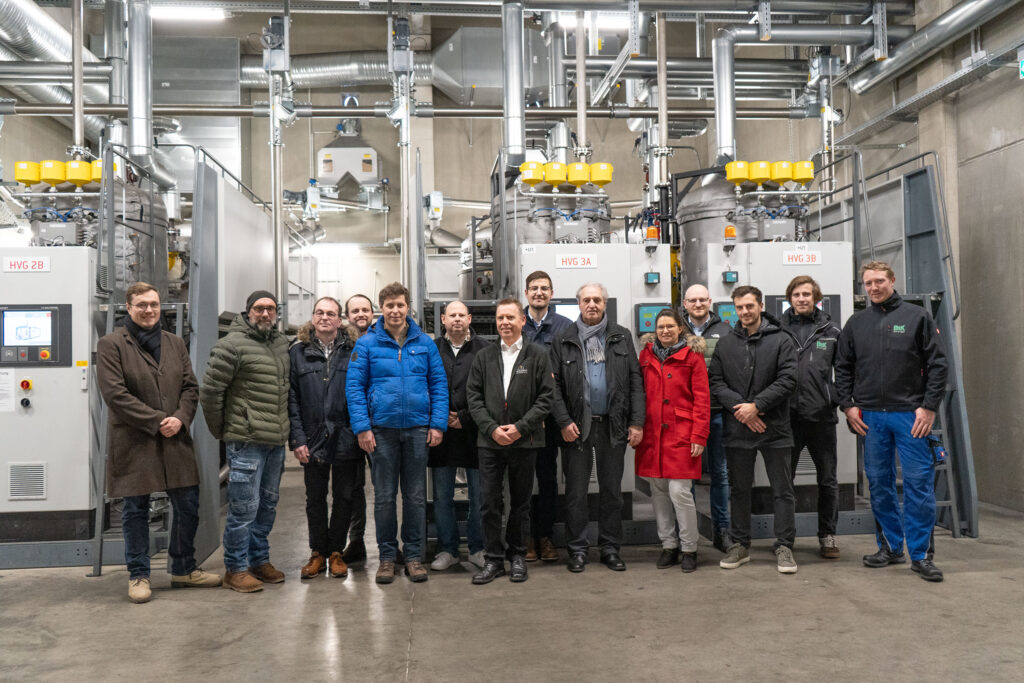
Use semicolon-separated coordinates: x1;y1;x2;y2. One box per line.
522;270;572;562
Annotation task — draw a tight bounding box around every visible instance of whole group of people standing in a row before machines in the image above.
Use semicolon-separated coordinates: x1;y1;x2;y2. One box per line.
97;262;945;602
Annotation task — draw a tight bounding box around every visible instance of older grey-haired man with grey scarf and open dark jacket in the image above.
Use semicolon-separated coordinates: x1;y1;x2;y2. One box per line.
551;283;646;572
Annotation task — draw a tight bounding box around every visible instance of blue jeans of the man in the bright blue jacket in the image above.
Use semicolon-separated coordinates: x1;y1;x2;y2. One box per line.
370;427;427;562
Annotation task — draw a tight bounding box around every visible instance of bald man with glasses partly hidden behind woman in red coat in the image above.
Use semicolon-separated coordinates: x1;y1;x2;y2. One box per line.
683;285;732;553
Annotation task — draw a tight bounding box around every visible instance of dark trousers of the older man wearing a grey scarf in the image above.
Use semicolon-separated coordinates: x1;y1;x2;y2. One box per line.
562;420;626;557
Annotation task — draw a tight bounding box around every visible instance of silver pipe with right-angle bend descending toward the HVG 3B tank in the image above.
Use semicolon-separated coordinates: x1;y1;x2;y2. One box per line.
712;24;874;165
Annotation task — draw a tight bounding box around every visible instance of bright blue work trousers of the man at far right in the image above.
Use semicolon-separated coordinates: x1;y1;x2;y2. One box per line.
861;411;935;560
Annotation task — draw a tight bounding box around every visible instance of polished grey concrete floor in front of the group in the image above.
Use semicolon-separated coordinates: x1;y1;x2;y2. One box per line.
0;467;1024;681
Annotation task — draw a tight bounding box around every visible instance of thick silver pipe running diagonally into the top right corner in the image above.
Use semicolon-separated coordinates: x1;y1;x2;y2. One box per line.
849;0;1020;95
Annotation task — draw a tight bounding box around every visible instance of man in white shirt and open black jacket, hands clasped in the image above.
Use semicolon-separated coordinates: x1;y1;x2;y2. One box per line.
466;299;555;585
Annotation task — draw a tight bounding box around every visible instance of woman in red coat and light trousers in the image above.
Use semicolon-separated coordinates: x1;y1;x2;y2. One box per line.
636;308;711;572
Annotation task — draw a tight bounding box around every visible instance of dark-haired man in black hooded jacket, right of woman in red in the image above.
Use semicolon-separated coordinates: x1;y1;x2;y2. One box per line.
709;285;797;573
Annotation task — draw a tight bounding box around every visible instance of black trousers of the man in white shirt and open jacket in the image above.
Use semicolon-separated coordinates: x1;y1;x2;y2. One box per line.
477;447;537;562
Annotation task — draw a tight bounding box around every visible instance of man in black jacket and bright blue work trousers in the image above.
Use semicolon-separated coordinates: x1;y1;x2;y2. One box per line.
836;261;946;582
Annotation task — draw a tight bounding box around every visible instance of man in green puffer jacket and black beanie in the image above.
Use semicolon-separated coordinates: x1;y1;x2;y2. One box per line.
200;290;290;593
